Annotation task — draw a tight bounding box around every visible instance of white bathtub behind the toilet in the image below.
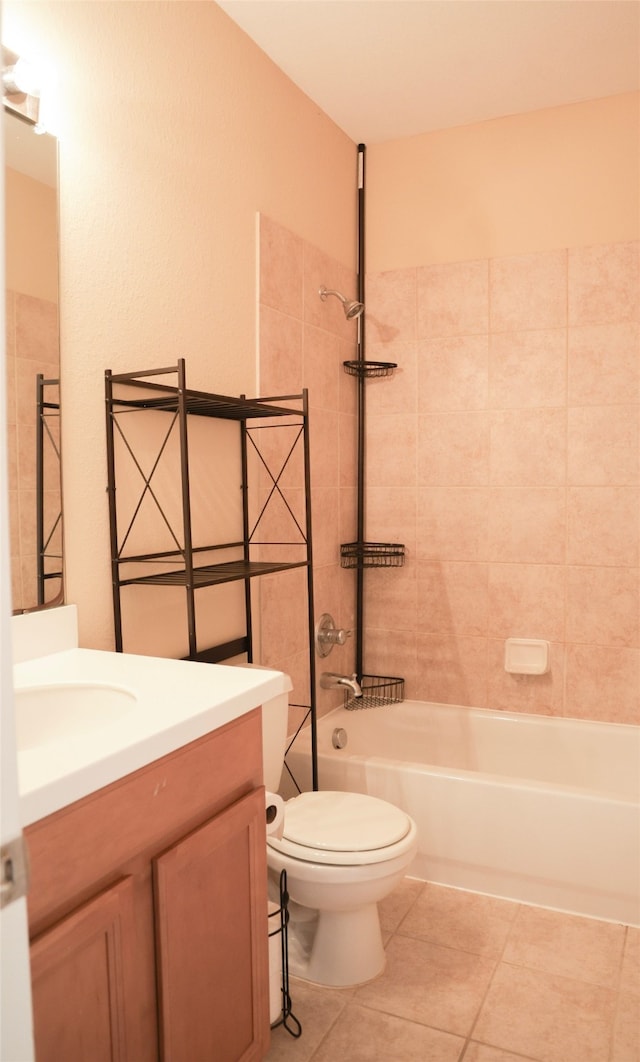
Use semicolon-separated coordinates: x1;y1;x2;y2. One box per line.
287;701;640;925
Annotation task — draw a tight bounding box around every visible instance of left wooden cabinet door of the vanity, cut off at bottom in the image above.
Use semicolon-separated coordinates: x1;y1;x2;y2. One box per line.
31;877;136;1062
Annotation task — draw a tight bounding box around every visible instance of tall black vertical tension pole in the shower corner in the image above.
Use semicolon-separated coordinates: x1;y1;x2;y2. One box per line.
356;143;366;681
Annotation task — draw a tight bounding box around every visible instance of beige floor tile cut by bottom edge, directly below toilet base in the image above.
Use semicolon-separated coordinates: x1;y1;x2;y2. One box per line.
313;1004;464;1062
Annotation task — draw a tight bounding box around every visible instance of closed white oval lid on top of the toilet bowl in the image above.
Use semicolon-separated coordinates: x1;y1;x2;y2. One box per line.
282;792;411;852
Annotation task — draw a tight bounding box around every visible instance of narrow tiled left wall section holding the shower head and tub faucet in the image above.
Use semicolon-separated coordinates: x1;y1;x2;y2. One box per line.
259;216;358;733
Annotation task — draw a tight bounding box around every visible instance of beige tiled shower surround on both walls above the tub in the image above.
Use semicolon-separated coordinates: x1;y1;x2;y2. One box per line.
260;219;640;723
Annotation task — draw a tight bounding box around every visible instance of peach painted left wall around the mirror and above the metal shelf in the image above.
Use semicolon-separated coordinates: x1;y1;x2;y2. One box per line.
3;0;357;652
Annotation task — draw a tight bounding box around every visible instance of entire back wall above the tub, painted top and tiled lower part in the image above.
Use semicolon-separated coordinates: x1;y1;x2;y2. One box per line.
365;96;640;722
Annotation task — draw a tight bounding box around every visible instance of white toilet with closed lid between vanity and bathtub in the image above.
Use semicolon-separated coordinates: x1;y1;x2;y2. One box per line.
257;671;417;987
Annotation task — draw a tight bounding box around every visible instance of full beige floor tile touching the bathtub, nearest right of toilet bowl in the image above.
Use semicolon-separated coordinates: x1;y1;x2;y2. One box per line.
399;884;519;958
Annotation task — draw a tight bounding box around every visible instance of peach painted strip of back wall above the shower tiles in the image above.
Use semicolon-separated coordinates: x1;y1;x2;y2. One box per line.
366;92;640;273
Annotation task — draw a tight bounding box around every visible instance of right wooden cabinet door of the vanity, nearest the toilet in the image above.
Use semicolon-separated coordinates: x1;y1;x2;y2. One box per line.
154;789;270;1062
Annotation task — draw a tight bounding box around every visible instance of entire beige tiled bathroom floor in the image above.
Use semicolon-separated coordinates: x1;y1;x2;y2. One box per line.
266;878;640;1062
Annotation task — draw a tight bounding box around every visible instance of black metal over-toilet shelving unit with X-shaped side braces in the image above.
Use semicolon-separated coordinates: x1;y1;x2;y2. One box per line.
105;358;317;789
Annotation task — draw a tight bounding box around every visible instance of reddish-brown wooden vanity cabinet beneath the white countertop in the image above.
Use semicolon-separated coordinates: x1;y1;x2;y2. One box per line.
25;709;270;1062
